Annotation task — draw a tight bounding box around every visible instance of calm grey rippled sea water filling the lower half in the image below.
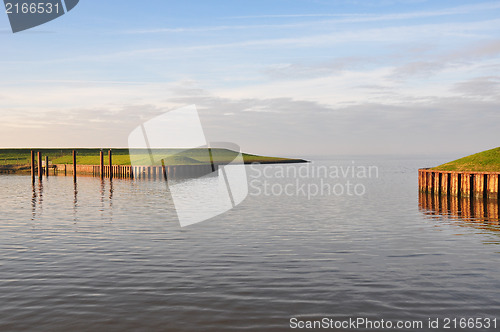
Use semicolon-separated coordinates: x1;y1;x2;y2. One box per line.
0;159;500;331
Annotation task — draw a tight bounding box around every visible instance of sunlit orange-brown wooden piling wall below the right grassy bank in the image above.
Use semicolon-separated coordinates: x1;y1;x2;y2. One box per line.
418;169;500;200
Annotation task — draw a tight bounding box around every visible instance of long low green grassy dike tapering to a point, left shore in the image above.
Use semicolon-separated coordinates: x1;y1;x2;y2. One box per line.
0;148;307;167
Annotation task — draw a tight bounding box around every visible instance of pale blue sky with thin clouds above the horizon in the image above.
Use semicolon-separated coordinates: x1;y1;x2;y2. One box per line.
0;0;500;156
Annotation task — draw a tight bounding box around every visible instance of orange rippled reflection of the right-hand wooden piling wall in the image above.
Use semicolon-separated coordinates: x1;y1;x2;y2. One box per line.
418;192;500;231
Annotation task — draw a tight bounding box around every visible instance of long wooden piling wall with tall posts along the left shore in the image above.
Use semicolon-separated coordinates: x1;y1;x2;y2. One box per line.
31;150;218;181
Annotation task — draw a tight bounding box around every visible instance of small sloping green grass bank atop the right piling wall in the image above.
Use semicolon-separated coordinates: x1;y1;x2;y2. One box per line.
432;147;500;172
